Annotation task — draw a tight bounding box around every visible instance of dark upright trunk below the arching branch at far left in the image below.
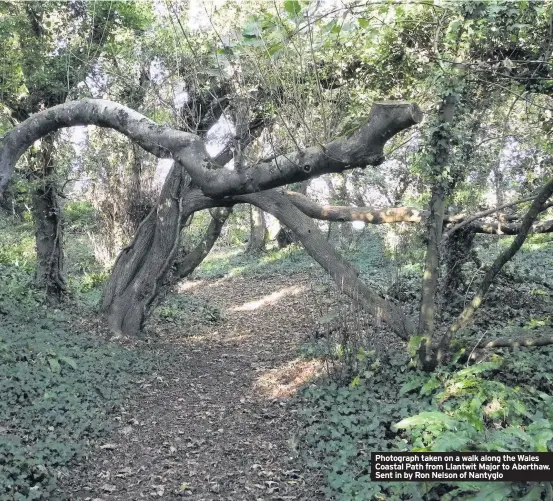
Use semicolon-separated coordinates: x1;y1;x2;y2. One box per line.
33;136;66;301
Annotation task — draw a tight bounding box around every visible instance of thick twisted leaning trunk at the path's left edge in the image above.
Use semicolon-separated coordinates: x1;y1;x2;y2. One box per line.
101;162;214;336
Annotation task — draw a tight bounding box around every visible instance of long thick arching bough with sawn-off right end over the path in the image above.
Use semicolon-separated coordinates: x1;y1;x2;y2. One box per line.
0;99;422;198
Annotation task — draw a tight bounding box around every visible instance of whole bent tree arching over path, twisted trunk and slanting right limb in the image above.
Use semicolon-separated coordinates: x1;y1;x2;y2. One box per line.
0;100;421;336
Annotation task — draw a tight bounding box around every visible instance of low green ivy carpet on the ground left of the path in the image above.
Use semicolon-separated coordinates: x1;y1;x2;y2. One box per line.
0;313;151;501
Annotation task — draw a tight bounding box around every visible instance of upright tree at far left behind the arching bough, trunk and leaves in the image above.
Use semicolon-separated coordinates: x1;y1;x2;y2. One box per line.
0;1;153;299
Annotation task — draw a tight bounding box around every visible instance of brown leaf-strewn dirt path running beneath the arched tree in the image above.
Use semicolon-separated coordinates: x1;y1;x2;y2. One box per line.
63;273;324;501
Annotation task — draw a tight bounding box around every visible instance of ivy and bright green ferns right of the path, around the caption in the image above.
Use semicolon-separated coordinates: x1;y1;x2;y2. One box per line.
301;351;553;501
